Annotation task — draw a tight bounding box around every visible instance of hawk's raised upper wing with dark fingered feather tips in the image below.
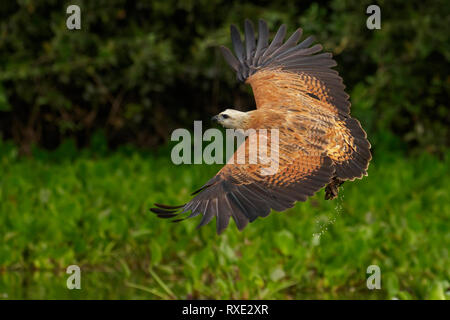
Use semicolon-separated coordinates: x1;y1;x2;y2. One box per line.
220;20;350;115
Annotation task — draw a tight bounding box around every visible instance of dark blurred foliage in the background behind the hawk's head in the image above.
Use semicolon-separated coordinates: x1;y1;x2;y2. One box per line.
0;0;450;154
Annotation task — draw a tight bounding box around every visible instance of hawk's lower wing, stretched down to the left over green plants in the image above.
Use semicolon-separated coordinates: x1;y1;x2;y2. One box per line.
150;127;334;234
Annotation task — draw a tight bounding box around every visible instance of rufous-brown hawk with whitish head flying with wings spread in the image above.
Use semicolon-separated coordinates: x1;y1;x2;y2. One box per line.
150;20;372;234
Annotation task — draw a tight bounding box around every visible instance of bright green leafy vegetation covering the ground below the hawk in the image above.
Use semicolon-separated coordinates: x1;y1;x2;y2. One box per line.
0;139;450;299
